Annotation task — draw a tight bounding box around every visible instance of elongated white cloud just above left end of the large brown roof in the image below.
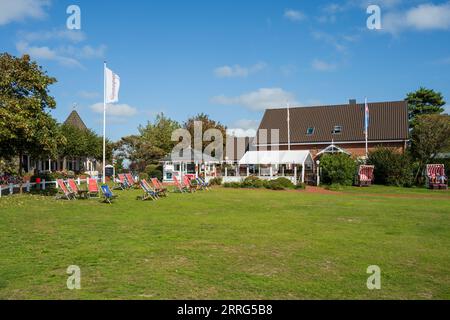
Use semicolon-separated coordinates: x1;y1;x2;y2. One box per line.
211;88;296;111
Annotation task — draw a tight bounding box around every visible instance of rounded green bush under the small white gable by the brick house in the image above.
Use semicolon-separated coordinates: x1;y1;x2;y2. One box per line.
320;153;356;186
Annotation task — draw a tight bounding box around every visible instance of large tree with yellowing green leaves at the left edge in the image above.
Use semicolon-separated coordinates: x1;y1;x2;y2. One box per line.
0;53;64;175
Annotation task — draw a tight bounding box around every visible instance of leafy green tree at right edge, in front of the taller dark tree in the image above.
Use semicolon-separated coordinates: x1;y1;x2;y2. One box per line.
411;114;450;182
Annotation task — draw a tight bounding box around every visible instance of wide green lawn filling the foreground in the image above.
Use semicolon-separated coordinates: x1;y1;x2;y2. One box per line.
0;187;450;299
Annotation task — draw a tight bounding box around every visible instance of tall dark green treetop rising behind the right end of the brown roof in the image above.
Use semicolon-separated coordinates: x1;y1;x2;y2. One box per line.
406;87;446;128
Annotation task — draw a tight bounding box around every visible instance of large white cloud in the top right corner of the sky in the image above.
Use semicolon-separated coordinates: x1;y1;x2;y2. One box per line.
382;2;450;34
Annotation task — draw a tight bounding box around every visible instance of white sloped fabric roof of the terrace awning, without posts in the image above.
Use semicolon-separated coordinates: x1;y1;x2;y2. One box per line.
239;150;313;165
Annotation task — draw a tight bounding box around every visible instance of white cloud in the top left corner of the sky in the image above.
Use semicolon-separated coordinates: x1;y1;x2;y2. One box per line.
0;0;50;25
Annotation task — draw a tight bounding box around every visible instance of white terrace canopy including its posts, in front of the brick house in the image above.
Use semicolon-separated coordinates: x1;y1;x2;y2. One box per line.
239;150;314;182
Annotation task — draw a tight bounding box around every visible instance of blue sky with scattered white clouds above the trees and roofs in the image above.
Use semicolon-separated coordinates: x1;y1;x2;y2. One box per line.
0;0;450;140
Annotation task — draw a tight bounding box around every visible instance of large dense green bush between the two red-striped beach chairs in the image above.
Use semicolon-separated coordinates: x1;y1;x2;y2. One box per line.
367;147;414;187
